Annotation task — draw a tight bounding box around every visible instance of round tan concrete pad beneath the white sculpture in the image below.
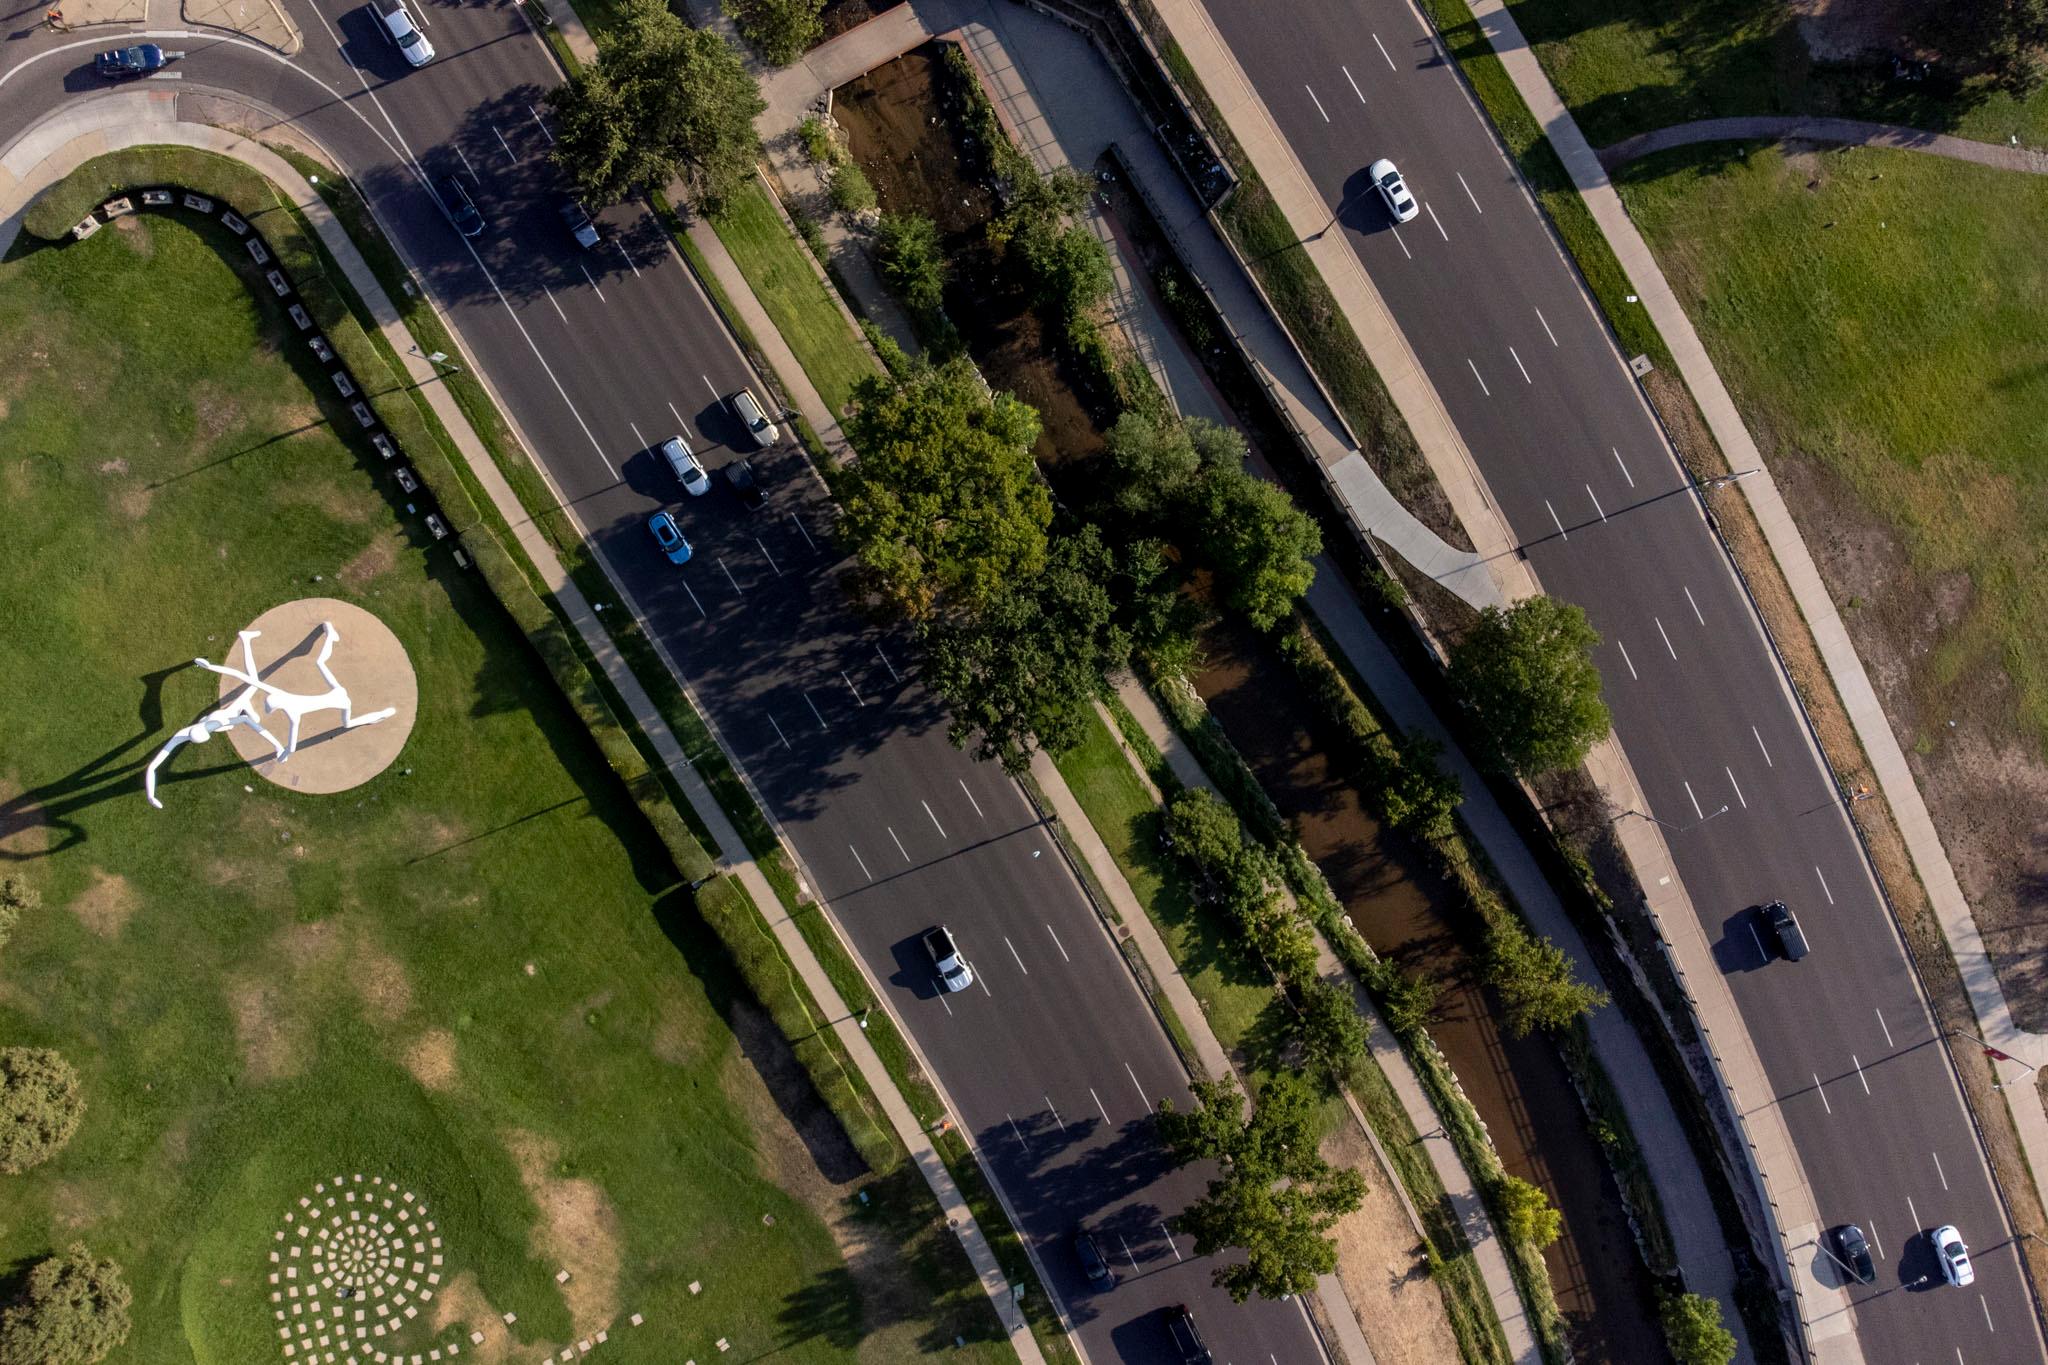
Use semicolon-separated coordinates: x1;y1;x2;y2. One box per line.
213;598;420;792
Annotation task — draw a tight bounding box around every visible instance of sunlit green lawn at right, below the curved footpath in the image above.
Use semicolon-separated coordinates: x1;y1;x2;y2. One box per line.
1624;149;2048;743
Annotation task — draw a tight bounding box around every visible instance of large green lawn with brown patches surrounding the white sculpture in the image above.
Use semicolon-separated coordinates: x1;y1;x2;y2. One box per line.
0;205;1001;1365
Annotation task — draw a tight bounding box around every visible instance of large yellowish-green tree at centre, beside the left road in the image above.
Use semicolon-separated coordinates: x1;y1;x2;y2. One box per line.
840;360;1053;622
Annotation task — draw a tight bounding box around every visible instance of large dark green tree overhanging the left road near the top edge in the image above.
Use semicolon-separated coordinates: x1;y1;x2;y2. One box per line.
547;0;766;213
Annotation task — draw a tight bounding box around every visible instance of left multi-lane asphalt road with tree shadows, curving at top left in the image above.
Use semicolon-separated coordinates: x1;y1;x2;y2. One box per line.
0;0;1323;1365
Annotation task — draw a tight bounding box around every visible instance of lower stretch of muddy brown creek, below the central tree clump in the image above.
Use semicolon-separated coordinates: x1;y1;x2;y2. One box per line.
1196;626;1671;1365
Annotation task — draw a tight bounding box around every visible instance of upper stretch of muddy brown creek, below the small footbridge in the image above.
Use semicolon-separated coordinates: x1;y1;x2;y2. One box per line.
831;43;1114;472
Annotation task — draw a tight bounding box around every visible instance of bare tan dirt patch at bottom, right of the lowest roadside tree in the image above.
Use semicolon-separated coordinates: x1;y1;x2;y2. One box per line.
1323;1121;1458;1365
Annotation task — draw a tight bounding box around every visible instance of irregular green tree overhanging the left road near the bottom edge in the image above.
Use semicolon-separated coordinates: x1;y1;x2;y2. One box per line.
1159;1072;1366;1304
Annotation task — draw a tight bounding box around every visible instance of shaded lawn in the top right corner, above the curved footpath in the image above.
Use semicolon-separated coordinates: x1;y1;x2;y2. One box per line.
1507;0;2048;147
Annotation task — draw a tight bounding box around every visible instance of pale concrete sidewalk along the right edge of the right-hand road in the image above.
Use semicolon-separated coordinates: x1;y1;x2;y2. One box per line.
1470;0;2048;1326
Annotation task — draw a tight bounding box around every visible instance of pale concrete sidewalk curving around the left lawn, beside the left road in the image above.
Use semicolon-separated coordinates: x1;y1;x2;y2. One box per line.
0;92;1044;1365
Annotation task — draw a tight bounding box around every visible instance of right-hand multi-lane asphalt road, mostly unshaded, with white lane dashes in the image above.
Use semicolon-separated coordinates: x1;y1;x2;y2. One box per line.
1206;0;2042;1361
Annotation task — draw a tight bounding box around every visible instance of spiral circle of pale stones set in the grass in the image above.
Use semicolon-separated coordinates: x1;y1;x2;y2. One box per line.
270;1175;463;1365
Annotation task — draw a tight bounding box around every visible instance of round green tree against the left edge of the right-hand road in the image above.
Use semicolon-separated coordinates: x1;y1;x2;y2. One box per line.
1450;596;1610;778
